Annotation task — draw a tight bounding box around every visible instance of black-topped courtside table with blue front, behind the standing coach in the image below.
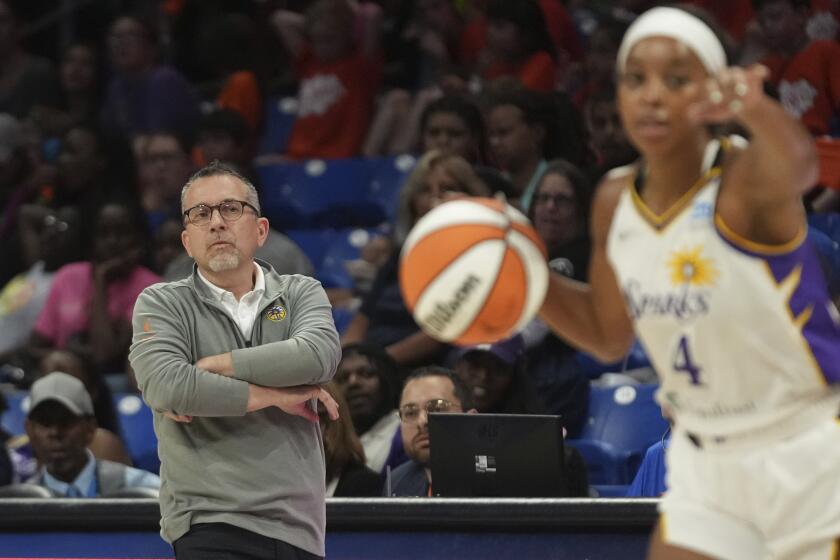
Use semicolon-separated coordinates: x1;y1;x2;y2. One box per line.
0;498;656;560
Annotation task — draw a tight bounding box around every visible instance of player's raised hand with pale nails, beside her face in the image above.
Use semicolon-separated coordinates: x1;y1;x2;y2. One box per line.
688;64;770;124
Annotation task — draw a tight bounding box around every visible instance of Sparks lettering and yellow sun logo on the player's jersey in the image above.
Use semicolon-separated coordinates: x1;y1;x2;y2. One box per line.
624;245;719;320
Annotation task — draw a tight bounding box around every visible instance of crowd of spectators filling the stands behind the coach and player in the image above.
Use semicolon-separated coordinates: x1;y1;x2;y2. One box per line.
0;0;840;495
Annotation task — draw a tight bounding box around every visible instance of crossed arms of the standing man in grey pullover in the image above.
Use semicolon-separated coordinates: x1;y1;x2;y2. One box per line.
129;281;340;421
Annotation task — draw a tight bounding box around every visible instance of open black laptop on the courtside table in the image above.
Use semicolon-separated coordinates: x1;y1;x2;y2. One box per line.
429;413;567;498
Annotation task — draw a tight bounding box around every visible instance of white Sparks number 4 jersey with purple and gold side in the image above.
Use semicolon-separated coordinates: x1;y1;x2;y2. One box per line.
607;141;840;436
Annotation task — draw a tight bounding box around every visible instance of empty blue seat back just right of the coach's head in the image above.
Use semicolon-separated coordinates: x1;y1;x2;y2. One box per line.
257;159;374;230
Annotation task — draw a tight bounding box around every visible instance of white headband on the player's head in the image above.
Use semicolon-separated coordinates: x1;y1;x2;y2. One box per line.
617;7;726;75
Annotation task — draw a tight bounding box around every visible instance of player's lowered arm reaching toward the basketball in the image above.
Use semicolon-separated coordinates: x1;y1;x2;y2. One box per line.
540;178;634;362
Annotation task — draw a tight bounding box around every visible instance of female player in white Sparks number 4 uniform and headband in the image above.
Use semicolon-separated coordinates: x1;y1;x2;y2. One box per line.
541;8;840;560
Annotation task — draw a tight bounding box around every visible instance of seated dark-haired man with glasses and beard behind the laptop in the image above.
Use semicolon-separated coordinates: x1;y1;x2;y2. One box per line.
385;366;475;496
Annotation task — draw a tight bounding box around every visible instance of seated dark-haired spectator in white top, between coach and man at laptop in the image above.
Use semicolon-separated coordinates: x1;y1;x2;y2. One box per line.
333;344;401;473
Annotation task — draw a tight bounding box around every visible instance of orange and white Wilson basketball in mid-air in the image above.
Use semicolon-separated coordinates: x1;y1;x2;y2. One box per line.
399;198;548;345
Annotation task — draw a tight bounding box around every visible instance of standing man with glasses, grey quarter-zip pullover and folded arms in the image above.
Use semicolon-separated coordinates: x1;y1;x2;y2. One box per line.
129;163;341;560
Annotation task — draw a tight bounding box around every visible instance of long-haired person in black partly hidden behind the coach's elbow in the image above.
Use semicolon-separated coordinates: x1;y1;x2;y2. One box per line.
318;382;382;497
